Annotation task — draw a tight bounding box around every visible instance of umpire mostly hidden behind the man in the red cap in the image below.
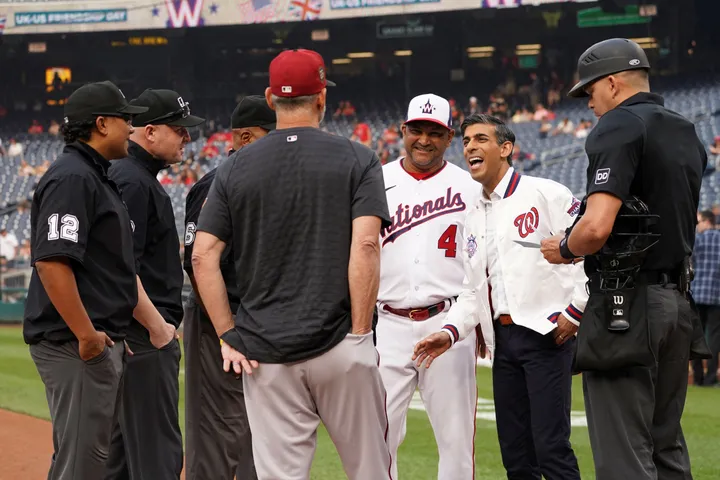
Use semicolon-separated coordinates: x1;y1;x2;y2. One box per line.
183;95;275;480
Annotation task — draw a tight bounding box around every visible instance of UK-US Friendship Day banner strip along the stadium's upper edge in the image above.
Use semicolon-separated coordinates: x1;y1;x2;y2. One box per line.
0;0;596;35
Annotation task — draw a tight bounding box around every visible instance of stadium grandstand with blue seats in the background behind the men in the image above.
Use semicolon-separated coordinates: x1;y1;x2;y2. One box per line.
0;0;720;288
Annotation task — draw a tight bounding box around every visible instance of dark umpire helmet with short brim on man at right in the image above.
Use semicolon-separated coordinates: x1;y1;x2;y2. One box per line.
568;38;650;98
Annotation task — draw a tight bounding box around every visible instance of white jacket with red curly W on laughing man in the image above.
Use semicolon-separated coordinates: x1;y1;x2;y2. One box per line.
443;168;588;358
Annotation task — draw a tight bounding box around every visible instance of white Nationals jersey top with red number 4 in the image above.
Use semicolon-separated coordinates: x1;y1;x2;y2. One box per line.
378;160;482;308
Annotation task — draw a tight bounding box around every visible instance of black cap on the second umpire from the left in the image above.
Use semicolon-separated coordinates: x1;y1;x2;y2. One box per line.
130;88;205;127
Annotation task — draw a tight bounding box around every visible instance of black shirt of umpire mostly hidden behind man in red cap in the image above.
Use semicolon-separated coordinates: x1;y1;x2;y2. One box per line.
183;168;240;311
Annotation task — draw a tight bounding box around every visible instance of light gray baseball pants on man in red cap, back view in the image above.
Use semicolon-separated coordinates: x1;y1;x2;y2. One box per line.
243;332;391;480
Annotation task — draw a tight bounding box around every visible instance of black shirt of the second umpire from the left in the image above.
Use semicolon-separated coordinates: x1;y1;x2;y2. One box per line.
109;142;185;341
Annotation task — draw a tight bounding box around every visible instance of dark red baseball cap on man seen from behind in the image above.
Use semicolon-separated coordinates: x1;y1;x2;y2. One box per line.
270;49;335;97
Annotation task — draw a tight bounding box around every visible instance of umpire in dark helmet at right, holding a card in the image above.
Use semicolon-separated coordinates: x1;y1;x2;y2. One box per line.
542;39;707;480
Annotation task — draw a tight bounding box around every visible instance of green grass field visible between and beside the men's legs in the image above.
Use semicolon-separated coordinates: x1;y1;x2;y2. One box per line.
0;328;720;480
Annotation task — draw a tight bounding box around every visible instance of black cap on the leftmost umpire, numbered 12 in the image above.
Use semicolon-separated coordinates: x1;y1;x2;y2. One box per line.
64;81;148;123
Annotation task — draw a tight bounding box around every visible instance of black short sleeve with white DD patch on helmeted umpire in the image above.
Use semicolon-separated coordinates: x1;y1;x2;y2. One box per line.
585;108;645;201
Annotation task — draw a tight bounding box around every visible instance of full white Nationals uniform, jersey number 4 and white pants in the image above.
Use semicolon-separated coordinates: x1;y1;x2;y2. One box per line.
377;160;482;480
